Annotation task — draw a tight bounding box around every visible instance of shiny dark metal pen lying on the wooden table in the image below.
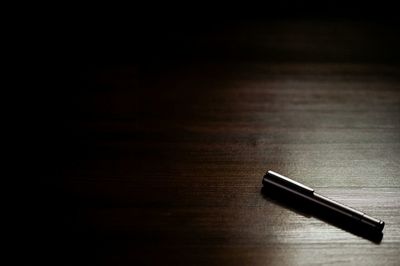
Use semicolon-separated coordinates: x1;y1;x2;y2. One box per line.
262;171;385;231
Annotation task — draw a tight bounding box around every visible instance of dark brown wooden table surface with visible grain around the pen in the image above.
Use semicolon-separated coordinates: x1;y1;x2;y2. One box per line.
28;21;400;265
